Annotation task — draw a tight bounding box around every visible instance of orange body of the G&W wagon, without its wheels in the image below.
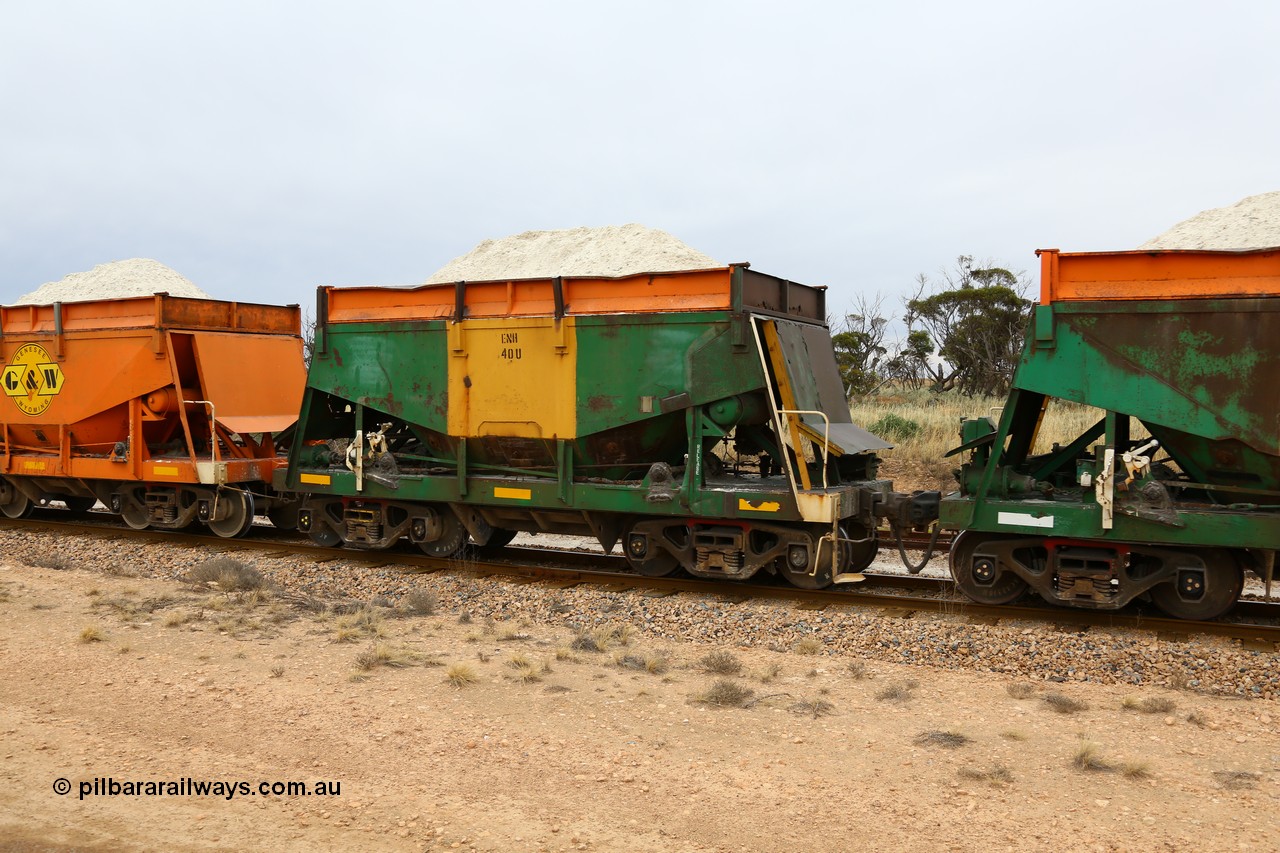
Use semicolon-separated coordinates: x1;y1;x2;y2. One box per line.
0;295;306;483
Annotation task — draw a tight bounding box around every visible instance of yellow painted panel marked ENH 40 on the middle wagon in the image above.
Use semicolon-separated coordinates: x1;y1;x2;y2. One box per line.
448;316;577;439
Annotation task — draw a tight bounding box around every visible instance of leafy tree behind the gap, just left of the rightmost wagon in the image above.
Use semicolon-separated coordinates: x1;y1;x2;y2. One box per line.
906;255;1032;396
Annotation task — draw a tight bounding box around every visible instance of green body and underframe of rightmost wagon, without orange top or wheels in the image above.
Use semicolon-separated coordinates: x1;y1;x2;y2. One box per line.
941;298;1280;549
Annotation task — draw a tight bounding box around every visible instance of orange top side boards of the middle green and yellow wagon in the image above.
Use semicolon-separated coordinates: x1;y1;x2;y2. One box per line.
325;266;733;323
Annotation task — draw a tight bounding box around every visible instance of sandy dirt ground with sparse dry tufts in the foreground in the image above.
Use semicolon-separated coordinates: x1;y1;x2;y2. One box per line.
0;564;1280;852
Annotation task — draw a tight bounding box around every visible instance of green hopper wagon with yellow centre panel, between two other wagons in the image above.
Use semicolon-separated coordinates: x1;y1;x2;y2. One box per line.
290;265;931;585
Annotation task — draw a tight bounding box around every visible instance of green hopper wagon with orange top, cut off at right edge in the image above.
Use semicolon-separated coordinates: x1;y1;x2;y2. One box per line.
941;250;1280;620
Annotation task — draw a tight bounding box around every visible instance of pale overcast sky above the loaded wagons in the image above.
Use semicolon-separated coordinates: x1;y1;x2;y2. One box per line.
0;0;1280;314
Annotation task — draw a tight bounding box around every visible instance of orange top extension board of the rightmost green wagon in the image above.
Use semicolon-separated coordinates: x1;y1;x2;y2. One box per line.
1036;248;1280;305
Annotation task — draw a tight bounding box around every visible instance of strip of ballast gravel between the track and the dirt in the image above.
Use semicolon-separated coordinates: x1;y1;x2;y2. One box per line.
12;530;1280;699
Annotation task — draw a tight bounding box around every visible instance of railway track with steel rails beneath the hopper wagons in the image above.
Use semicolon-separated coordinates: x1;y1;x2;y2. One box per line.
0;510;1280;652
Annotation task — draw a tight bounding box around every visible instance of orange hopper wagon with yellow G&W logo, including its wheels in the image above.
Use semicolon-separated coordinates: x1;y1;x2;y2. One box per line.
0;293;306;537
